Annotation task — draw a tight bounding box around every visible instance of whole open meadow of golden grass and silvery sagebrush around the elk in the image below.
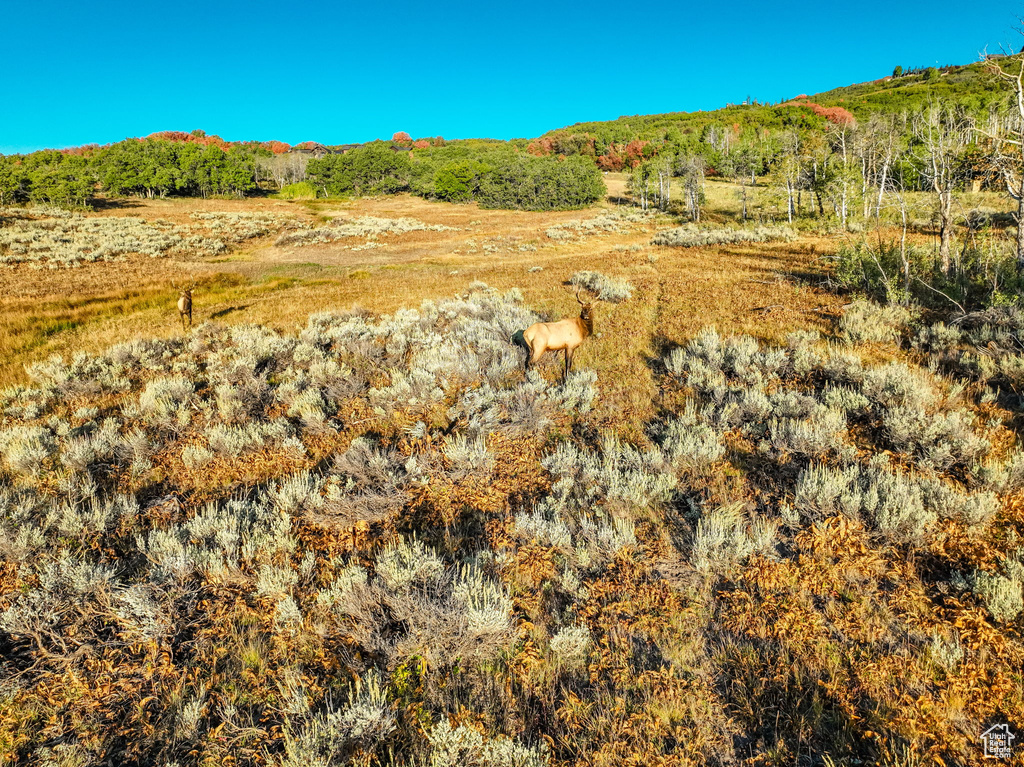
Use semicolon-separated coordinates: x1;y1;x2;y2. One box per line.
0;174;1024;767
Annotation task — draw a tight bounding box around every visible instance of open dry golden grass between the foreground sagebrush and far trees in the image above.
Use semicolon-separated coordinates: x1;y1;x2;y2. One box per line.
0;187;839;425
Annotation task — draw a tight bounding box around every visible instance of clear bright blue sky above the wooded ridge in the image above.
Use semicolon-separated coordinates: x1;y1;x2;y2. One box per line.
0;0;1024;154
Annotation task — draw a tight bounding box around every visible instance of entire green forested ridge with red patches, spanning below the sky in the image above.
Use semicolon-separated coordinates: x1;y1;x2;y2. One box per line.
0;57;1016;211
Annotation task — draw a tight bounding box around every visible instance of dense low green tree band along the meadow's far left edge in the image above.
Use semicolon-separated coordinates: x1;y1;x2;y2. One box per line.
0;138;605;210
